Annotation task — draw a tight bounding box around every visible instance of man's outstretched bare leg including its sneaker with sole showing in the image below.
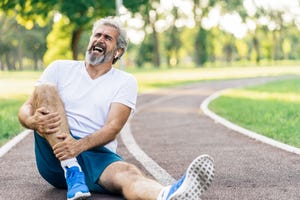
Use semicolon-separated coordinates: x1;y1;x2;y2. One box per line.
99;155;214;200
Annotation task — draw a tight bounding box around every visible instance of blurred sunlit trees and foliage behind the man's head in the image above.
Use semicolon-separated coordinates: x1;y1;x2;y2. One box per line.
0;0;300;70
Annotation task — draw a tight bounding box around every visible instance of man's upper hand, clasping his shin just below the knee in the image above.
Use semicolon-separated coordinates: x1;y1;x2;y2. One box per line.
30;107;61;135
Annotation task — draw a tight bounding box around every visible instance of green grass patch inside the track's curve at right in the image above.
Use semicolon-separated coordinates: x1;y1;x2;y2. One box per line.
209;77;300;147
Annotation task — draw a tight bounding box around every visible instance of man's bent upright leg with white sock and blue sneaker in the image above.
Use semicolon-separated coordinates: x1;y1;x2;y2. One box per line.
33;84;91;200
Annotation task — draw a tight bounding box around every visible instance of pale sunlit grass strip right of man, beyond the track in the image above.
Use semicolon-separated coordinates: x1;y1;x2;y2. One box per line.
127;66;300;93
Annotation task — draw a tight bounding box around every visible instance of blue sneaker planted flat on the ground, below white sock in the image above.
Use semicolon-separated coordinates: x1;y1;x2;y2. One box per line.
66;167;91;200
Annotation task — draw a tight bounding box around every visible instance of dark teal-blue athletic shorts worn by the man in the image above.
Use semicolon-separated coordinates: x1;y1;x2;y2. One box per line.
34;132;123;193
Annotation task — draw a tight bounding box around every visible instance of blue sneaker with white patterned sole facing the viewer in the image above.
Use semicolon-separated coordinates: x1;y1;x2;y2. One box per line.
160;155;214;200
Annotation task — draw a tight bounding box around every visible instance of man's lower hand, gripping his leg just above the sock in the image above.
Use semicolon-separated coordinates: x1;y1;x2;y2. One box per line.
52;134;82;160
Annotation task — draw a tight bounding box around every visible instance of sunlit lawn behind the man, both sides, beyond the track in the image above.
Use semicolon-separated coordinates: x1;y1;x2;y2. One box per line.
0;66;300;145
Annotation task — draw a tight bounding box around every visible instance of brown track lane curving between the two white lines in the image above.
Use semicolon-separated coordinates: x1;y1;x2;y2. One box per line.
131;78;300;200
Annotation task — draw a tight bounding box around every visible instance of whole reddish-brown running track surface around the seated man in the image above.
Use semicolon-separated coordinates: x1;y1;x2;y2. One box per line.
0;78;300;200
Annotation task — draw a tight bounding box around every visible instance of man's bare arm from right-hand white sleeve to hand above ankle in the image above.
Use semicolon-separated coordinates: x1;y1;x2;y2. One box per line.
53;103;131;160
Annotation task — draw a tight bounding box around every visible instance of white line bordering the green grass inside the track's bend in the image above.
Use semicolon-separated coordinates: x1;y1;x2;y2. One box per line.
200;89;300;155
